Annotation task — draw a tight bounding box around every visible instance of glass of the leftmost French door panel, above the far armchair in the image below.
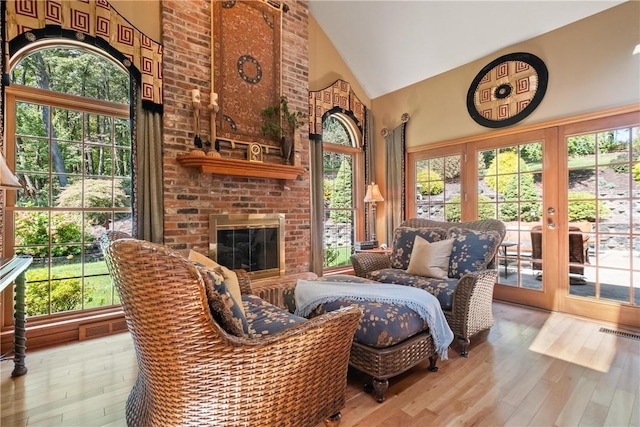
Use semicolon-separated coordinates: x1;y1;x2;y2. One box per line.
415;154;461;221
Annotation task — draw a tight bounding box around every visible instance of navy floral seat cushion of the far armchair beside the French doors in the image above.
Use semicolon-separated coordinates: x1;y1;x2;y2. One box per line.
369;268;458;310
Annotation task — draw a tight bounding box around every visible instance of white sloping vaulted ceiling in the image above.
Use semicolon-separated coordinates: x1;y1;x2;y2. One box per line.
309;0;623;99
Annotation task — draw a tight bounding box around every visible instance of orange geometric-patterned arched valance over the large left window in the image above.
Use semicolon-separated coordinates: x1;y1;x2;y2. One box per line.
3;0;162;111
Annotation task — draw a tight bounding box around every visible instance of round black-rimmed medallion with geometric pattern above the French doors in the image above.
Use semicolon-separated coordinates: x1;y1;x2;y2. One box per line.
467;52;549;128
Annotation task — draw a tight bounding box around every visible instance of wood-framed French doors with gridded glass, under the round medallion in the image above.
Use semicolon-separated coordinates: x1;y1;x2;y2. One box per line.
407;110;640;327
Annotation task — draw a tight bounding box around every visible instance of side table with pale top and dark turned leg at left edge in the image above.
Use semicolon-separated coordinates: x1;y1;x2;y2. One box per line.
0;256;33;377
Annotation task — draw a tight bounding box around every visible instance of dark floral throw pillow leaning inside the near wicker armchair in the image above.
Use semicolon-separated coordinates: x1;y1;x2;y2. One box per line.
198;267;249;337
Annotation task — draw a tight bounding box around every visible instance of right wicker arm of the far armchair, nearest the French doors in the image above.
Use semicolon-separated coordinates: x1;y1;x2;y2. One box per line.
445;270;498;338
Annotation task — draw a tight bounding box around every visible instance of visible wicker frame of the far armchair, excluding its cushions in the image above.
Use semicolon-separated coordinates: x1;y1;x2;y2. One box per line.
351;218;506;357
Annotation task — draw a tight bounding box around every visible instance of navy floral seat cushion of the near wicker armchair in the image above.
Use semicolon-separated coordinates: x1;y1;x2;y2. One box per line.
242;295;307;338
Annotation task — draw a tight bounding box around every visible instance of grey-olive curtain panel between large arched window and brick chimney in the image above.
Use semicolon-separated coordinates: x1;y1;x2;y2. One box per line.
135;97;164;243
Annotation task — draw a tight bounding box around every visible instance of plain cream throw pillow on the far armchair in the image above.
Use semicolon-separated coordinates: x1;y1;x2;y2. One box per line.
407;236;453;279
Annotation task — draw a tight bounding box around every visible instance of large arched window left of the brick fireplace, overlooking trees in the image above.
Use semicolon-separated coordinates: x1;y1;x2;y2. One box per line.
6;45;132;316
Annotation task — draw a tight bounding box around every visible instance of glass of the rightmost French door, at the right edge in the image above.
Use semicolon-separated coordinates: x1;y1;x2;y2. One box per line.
566;127;640;305
